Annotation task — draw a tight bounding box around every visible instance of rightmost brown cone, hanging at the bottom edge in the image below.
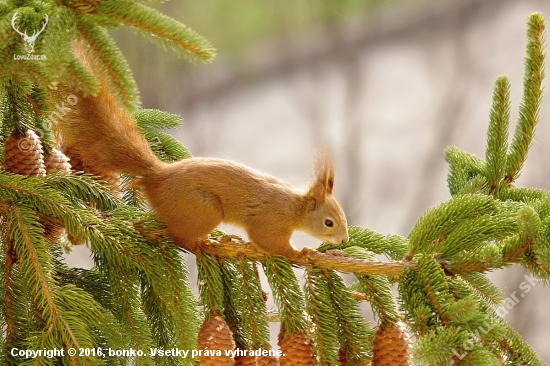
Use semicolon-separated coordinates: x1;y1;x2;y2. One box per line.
372;324;410;366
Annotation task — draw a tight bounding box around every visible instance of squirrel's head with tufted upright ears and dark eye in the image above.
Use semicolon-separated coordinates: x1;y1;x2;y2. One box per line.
302;151;349;244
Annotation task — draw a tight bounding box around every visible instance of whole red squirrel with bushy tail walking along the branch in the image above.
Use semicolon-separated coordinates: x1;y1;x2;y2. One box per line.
54;43;348;260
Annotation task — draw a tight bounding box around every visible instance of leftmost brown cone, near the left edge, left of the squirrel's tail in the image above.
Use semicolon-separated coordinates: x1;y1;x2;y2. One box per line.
4;130;46;177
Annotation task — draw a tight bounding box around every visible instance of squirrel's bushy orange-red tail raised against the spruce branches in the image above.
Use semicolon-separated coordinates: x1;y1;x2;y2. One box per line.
54;43;162;176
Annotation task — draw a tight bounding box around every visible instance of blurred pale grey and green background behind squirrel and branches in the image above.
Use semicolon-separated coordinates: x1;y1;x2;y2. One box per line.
73;0;550;362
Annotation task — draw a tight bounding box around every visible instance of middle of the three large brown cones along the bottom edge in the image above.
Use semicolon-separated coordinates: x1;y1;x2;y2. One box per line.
278;325;314;366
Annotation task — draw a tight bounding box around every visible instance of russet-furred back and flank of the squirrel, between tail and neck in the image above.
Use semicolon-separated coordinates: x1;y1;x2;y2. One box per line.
137;158;303;226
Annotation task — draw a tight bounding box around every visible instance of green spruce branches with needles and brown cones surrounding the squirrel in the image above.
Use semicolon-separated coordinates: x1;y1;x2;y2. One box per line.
0;0;550;366
